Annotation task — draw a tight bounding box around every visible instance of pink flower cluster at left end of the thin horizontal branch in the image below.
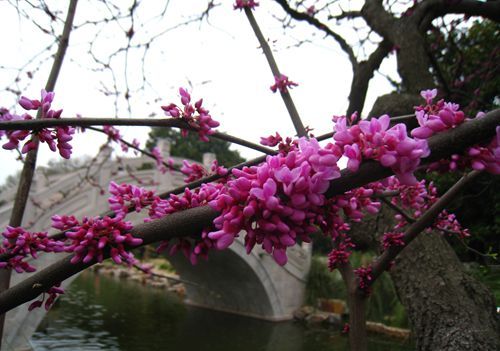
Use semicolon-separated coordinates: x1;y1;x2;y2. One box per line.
0;90;75;159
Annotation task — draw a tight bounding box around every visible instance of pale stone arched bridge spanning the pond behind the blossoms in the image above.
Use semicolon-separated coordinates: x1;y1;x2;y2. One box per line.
0;144;311;351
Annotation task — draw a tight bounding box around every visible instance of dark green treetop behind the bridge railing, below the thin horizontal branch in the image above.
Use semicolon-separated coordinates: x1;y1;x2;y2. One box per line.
146;128;245;167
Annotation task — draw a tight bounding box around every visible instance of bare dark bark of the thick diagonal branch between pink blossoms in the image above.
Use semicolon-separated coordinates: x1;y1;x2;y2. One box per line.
0;110;500;313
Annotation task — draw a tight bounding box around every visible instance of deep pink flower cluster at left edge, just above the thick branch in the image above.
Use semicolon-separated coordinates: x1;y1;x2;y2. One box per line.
0;226;64;273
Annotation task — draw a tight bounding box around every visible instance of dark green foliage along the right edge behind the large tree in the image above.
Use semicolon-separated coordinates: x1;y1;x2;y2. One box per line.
425;20;500;263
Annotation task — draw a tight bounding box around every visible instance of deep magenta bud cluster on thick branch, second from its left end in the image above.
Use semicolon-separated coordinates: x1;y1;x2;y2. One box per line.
52;216;142;264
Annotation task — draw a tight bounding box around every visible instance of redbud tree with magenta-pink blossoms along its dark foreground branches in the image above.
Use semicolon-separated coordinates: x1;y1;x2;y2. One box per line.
0;0;500;350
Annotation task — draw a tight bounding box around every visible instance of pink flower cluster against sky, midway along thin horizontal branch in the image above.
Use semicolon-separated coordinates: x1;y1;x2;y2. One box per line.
161;88;219;142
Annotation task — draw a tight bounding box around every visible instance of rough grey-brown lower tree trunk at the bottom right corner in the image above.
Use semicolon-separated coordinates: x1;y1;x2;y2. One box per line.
390;233;500;351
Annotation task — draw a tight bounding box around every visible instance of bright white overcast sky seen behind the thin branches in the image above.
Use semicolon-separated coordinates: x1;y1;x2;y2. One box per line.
0;0;395;183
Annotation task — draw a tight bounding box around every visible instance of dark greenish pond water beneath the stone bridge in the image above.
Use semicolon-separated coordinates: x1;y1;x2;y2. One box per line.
32;272;412;351
